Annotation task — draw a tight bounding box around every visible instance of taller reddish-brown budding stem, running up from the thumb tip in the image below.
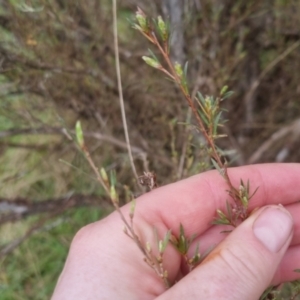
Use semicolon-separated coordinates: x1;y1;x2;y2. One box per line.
134;8;248;216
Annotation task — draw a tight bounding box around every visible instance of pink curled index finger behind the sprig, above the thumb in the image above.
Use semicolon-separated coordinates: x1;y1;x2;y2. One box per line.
137;163;300;235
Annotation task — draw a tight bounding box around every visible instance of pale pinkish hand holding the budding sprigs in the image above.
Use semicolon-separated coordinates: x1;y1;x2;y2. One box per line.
52;164;300;300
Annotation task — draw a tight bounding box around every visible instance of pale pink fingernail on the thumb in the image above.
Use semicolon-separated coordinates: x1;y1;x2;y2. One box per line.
253;206;293;253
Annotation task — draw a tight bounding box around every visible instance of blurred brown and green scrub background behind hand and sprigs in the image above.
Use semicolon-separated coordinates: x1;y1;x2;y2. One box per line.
0;0;300;300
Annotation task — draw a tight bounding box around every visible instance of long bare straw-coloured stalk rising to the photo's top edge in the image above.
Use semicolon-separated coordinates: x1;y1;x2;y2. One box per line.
113;0;138;182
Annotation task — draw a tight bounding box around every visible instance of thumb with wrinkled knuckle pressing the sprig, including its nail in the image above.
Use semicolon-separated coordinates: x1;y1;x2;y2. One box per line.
158;206;293;300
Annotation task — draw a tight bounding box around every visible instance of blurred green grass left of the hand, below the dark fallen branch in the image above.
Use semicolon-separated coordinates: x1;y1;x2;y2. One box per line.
0;208;107;300
